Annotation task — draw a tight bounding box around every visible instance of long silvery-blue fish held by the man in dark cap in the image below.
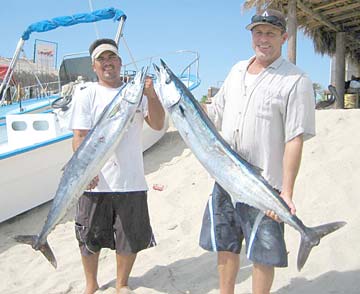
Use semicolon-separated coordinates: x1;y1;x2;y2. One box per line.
154;60;346;271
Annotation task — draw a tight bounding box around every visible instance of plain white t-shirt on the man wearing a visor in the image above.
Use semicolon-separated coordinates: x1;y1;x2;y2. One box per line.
69;83;148;192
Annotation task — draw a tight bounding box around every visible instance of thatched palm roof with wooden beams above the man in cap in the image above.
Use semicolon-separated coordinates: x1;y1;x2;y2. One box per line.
244;0;360;60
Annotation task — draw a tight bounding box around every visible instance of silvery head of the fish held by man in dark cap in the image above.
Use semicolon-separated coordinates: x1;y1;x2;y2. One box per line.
153;60;182;110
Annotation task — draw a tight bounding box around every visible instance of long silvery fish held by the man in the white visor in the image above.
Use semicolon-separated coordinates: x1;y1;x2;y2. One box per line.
15;68;147;268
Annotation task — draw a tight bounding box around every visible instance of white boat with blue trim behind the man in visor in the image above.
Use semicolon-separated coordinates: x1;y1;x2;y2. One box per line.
0;8;200;222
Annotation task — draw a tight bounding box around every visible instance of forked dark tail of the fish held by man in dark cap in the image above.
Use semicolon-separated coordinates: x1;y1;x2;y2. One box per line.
297;222;346;271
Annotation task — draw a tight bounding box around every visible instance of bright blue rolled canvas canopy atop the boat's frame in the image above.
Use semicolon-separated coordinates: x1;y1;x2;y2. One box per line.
21;7;126;41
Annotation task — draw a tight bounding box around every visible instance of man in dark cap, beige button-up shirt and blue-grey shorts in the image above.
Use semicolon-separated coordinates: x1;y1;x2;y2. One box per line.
200;9;315;294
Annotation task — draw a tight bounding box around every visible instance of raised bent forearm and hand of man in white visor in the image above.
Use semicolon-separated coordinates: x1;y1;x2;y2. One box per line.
144;78;165;131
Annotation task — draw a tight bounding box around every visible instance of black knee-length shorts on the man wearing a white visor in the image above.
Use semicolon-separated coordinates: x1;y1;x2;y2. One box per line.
75;191;156;255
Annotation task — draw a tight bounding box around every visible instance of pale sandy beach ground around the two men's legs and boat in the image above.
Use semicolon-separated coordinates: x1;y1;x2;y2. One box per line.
0;109;360;294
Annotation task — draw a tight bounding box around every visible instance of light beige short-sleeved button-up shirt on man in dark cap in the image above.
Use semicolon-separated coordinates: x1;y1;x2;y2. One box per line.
208;57;315;190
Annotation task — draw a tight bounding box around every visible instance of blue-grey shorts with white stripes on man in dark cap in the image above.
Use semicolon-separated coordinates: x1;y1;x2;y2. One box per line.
200;183;288;267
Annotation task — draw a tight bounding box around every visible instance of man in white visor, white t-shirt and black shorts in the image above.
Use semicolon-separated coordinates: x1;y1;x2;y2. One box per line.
70;39;165;294
